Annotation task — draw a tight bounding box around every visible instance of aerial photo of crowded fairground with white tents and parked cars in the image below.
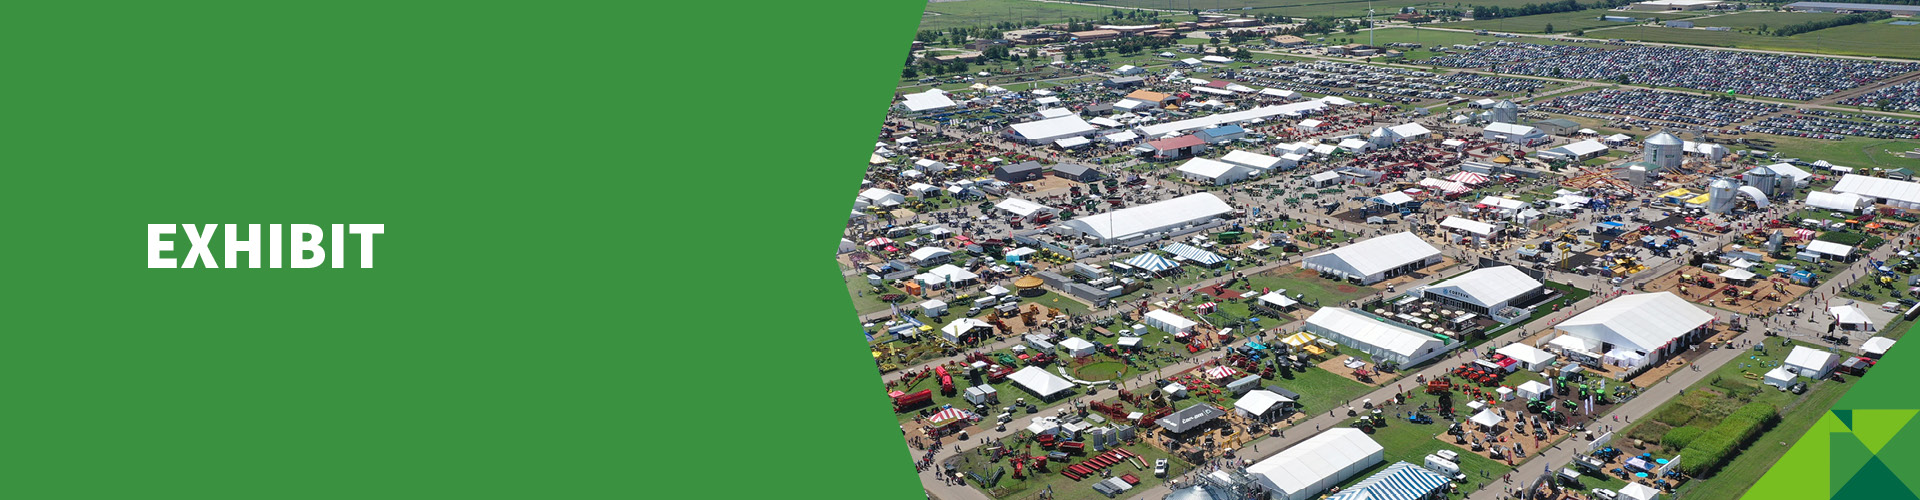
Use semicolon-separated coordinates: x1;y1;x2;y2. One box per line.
835;0;1920;500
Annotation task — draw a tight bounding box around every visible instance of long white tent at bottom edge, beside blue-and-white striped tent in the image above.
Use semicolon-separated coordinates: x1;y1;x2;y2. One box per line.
1246;427;1386;500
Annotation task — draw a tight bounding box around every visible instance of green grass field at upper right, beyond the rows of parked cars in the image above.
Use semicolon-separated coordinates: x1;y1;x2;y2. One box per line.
1590;23;1920;60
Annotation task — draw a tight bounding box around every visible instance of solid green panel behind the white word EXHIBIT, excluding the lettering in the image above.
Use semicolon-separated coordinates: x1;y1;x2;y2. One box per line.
0;2;924;498
